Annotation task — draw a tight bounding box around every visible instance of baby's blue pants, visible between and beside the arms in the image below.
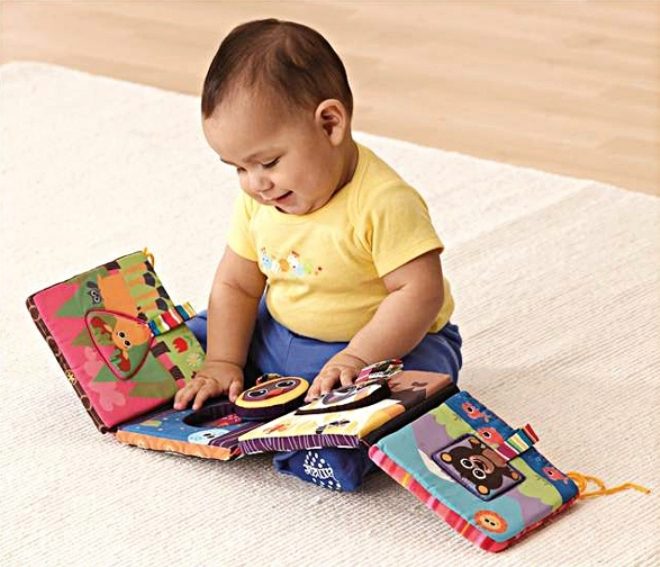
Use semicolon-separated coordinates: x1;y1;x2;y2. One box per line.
186;296;463;388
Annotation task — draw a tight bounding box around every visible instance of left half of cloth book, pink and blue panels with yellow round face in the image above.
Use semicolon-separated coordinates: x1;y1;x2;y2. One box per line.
27;250;308;460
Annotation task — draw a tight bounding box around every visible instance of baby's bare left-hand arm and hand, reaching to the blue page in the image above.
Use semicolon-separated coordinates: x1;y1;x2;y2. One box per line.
174;247;266;409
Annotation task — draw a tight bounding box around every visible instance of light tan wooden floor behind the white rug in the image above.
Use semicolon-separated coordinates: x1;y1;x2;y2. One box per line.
0;0;660;195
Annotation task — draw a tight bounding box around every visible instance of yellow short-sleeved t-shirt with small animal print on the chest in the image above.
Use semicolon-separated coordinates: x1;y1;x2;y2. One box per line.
228;144;454;341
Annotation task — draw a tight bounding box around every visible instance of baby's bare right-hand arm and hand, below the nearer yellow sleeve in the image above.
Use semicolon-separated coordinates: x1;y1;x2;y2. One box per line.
306;250;444;400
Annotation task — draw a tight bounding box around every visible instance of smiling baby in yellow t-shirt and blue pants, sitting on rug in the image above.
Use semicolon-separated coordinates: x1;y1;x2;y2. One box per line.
175;19;461;409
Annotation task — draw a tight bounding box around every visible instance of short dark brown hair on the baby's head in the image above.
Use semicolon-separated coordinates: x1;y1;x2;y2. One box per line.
202;18;353;118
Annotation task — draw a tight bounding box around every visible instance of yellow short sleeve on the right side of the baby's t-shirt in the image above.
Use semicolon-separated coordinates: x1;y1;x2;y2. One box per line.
361;182;444;277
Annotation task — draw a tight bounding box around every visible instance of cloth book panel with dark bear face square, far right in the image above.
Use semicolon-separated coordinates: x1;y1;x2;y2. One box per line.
369;391;578;551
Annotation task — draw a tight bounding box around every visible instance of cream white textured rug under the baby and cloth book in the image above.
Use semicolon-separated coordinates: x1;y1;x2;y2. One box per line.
0;63;660;567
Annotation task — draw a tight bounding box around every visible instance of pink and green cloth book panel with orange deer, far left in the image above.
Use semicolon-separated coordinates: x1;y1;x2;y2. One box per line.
27;251;204;433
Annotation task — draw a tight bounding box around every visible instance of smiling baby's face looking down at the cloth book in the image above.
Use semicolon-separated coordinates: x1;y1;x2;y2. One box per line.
203;91;343;215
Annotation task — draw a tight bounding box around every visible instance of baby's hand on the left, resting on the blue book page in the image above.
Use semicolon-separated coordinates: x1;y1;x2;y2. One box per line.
174;360;243;410
